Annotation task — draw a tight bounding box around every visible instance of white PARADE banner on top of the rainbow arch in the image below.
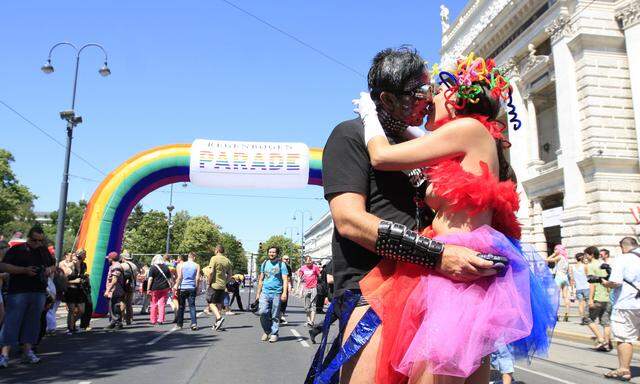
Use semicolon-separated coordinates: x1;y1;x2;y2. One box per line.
189;139;309;188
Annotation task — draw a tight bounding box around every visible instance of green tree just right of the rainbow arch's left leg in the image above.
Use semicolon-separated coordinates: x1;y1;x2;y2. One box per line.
123;210;168;254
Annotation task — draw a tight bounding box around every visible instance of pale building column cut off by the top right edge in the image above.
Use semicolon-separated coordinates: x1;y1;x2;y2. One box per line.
616;0;640;166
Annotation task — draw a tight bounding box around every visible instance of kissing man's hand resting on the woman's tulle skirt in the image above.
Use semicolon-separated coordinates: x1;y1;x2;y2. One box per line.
436;244;497;281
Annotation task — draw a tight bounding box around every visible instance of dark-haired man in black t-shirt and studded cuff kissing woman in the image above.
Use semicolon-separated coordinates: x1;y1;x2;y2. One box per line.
307;48;495;383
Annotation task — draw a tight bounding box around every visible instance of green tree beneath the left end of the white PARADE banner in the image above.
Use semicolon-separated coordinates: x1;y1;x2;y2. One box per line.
178;216;221;264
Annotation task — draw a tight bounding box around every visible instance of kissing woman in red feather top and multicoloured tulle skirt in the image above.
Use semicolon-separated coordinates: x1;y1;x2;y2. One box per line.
358;55;557;384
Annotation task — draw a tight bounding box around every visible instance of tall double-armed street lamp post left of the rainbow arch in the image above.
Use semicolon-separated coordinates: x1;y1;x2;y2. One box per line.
40;42;111;262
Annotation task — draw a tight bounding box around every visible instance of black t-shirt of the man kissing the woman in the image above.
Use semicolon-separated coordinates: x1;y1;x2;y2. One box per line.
322;119;424;296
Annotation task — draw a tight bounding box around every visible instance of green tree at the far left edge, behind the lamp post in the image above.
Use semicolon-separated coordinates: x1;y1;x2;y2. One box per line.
0;149;37;236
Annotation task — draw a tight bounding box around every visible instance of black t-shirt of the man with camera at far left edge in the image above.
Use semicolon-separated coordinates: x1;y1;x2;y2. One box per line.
2;244;53;294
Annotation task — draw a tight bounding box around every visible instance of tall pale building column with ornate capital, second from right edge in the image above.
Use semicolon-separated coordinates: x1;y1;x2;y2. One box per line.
546;13;591;237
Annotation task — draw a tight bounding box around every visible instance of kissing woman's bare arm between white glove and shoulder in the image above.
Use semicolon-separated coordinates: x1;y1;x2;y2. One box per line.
367;118;490;171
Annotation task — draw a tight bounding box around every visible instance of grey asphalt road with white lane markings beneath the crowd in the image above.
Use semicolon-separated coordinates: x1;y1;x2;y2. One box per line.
0;292;640;384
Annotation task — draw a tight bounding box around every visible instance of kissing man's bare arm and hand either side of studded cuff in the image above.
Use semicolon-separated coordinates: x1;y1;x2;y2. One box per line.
329;192;496;281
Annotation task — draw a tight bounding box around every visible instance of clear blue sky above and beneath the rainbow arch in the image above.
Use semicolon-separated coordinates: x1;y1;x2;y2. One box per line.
0;0;466;250
